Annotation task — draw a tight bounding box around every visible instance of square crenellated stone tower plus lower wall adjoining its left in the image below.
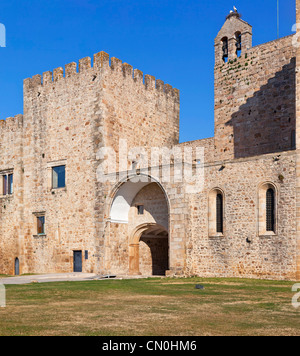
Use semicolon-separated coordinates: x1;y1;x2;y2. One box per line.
0;52;179;274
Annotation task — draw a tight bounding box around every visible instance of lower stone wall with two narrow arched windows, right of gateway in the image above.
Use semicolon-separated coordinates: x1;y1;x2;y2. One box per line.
187;152;297;279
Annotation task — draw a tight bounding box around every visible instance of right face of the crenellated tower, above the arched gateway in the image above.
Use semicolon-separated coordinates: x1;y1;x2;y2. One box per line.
101;54;179;159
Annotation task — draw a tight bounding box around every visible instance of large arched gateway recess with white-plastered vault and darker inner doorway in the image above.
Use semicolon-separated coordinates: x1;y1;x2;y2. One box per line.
109;175;169;276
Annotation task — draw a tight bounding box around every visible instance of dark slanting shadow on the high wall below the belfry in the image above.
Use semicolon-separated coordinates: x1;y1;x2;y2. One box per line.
226;58;296;158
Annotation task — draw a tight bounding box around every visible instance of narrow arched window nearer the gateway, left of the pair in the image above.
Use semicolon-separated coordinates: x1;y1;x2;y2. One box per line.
208;188;225;237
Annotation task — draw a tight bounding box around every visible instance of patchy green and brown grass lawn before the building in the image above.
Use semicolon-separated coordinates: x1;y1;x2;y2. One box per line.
0;278;300;336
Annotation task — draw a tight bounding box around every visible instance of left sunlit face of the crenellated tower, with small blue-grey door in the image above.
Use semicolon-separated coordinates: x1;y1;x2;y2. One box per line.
21;60;102;272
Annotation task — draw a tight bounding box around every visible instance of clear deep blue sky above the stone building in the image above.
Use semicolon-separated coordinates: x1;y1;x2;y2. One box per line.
0;0;295;142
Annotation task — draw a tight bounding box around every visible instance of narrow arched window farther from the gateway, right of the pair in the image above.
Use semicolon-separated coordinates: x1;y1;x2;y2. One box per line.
258;183;278;236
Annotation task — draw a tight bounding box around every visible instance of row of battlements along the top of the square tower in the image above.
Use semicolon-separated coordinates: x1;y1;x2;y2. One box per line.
24;52;180;101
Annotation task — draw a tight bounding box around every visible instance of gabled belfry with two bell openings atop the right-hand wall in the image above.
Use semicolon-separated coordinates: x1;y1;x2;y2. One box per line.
215;9;252;65
